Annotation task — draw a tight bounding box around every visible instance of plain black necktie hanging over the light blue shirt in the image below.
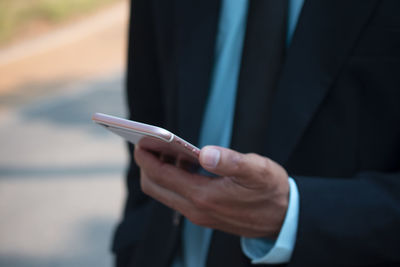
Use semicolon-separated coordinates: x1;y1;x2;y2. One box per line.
207;0;288;267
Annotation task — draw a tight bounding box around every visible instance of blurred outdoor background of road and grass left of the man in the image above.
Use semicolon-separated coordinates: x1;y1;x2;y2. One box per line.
0;0;129;267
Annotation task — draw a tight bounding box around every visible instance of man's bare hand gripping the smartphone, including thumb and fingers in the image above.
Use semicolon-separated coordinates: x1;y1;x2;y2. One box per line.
135;143;289;238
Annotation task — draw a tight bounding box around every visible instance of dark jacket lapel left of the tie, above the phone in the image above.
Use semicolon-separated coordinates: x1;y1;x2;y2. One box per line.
176;0;220;146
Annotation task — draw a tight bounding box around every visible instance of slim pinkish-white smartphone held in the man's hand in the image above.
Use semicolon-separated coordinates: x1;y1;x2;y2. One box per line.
92;113;200;164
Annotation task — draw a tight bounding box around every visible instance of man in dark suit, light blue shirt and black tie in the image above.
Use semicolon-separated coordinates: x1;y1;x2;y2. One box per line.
114;0;400;266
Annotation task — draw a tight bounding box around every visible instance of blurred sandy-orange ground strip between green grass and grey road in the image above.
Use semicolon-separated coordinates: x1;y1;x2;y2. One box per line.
0;0;128;95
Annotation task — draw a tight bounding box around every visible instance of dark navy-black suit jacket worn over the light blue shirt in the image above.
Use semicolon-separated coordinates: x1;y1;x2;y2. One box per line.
113;0;400;266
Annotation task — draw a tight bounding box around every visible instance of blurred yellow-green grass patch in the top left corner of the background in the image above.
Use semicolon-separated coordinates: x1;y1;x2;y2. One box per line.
0;0;118;44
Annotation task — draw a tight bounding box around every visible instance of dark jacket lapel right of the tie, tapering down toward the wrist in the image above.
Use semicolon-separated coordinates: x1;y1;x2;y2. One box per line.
265;0;378;164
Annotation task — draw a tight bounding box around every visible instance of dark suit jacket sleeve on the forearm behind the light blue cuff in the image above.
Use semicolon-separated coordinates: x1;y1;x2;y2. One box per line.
290;172;400;266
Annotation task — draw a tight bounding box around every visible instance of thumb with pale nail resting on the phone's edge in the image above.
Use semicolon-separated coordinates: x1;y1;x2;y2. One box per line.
200;146;266;177
